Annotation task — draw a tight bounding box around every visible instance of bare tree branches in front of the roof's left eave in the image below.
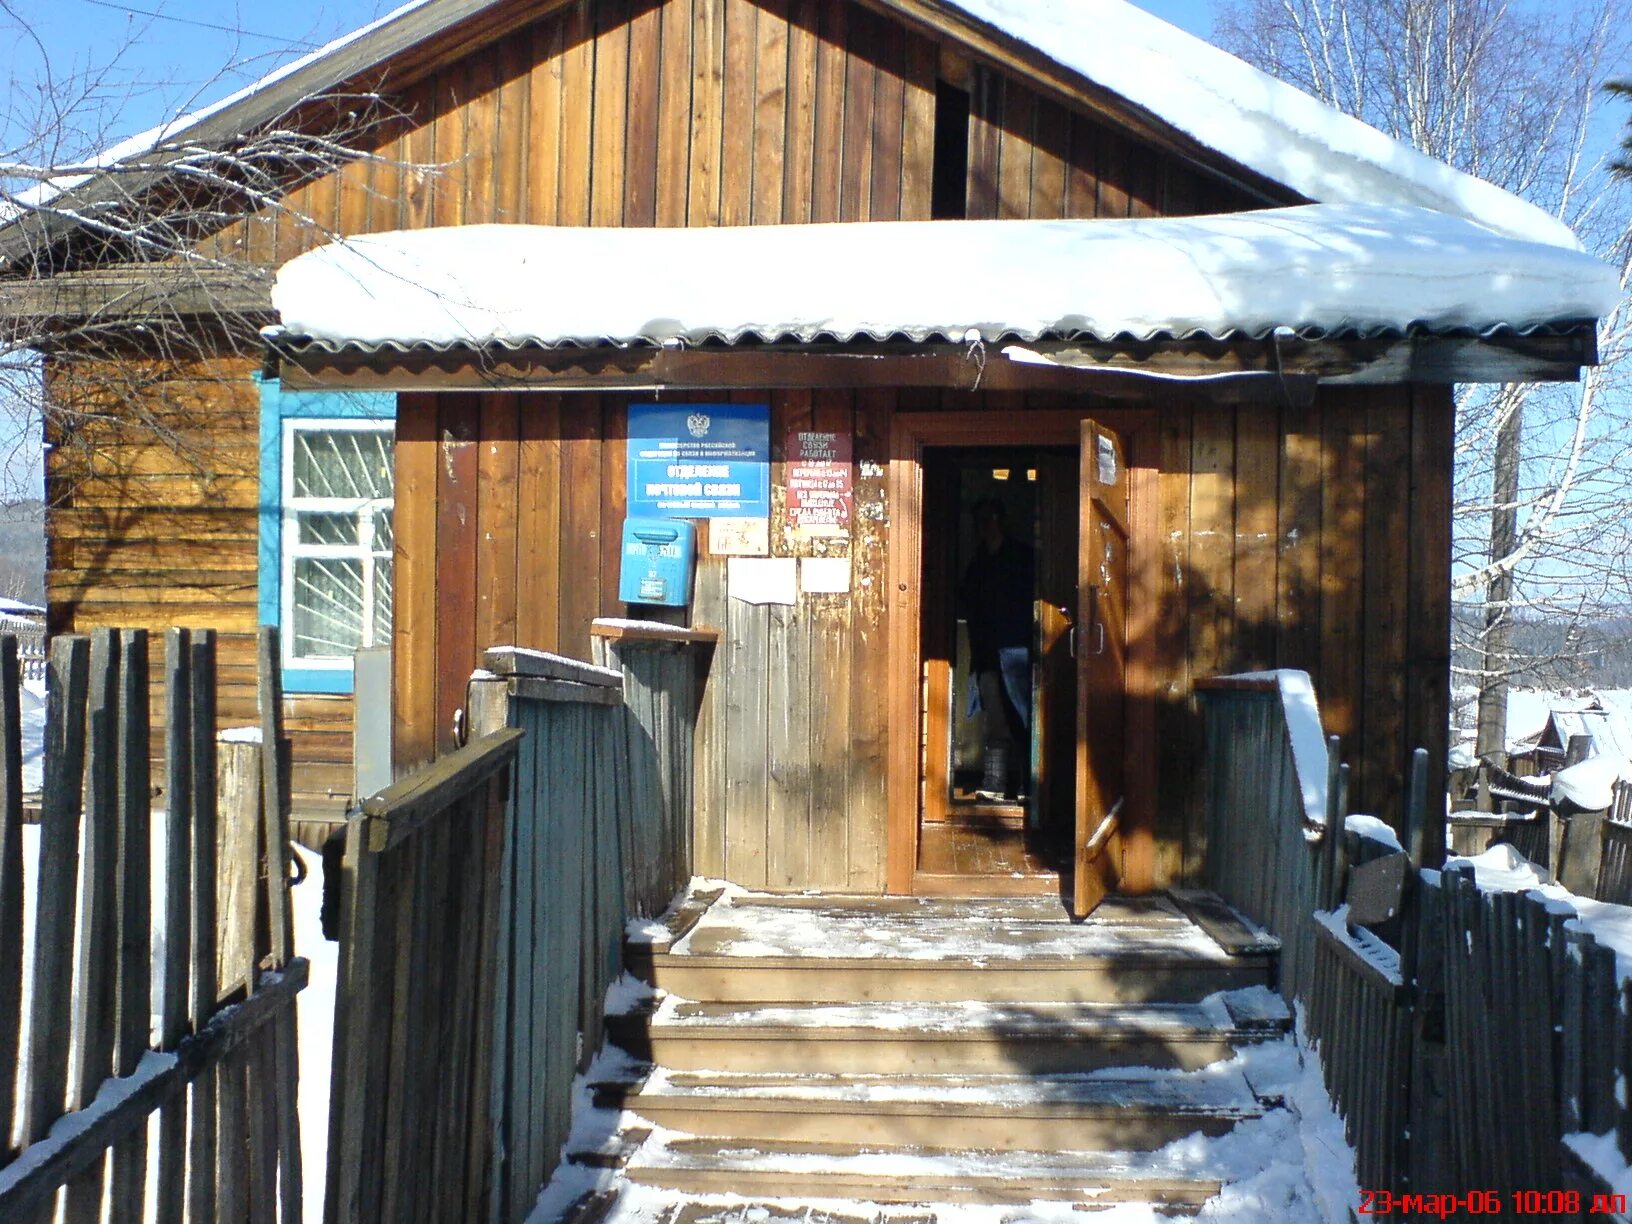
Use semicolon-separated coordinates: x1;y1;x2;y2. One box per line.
0;0;400;501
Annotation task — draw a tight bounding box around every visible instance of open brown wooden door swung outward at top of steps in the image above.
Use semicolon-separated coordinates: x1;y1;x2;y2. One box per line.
1074;421;1128;917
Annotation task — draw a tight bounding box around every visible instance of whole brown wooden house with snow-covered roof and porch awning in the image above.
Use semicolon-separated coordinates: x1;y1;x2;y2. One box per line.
5;0;1616;913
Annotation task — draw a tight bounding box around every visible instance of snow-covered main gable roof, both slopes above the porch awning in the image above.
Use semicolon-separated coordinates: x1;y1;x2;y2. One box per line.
0;0;1580;264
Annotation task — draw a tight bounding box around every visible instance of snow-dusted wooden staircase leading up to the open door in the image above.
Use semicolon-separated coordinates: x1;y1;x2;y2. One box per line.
554;889;1291;1224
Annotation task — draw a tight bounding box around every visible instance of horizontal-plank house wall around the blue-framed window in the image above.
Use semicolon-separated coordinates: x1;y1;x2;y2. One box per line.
46;359;351;821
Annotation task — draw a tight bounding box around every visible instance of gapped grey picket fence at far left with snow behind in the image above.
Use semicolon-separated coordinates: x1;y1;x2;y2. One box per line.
0;630;307;1224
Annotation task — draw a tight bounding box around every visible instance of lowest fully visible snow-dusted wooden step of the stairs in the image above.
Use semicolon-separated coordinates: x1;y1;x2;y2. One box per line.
625;1138;1221;1208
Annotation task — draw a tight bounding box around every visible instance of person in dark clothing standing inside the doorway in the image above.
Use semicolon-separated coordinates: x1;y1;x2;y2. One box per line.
958;498;1036;800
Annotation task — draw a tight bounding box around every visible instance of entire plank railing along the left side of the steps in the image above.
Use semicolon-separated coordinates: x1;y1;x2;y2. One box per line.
325;636;697;1224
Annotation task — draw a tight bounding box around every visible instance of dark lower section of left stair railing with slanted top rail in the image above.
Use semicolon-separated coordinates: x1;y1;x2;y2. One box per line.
323;730;522;1224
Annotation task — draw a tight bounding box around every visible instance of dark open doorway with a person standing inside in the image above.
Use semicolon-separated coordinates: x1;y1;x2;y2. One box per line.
917;447;1079;893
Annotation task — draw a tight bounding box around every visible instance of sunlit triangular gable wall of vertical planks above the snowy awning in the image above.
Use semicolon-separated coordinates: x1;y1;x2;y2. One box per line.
197;0;1253;264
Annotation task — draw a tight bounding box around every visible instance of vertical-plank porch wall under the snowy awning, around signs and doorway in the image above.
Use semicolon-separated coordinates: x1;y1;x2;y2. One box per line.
395;387;1451;891
